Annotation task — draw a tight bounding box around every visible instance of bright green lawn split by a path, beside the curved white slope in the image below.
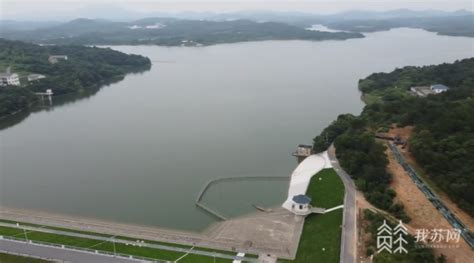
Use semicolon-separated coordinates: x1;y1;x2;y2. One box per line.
279;169;344;263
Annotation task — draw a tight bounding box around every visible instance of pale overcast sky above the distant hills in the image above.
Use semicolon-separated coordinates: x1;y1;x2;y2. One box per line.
0;0;474;19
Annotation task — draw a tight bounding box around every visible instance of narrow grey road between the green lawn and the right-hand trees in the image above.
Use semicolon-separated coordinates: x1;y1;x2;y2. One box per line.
328;145;357;263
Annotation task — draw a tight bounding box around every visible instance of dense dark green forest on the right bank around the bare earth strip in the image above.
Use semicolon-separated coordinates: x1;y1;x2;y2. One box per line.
314;58;474;221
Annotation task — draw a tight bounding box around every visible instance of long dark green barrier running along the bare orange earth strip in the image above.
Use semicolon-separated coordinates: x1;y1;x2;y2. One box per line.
388;143;474;249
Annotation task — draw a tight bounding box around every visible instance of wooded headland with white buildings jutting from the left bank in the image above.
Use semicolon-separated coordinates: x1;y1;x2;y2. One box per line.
0;39;151;118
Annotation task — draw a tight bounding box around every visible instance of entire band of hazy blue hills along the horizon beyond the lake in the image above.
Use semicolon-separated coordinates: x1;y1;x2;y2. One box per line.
0;8;474;46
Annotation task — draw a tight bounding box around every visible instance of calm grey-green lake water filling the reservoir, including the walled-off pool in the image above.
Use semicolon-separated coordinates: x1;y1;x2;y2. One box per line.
0;29;474;230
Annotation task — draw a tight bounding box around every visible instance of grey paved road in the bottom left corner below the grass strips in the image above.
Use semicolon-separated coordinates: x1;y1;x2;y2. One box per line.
0;239;152;263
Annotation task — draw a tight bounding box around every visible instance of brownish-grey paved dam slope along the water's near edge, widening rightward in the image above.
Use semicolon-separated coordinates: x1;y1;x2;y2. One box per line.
0;204;304;259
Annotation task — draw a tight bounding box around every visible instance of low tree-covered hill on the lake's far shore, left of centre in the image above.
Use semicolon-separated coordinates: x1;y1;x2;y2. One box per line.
2;18;364;46
